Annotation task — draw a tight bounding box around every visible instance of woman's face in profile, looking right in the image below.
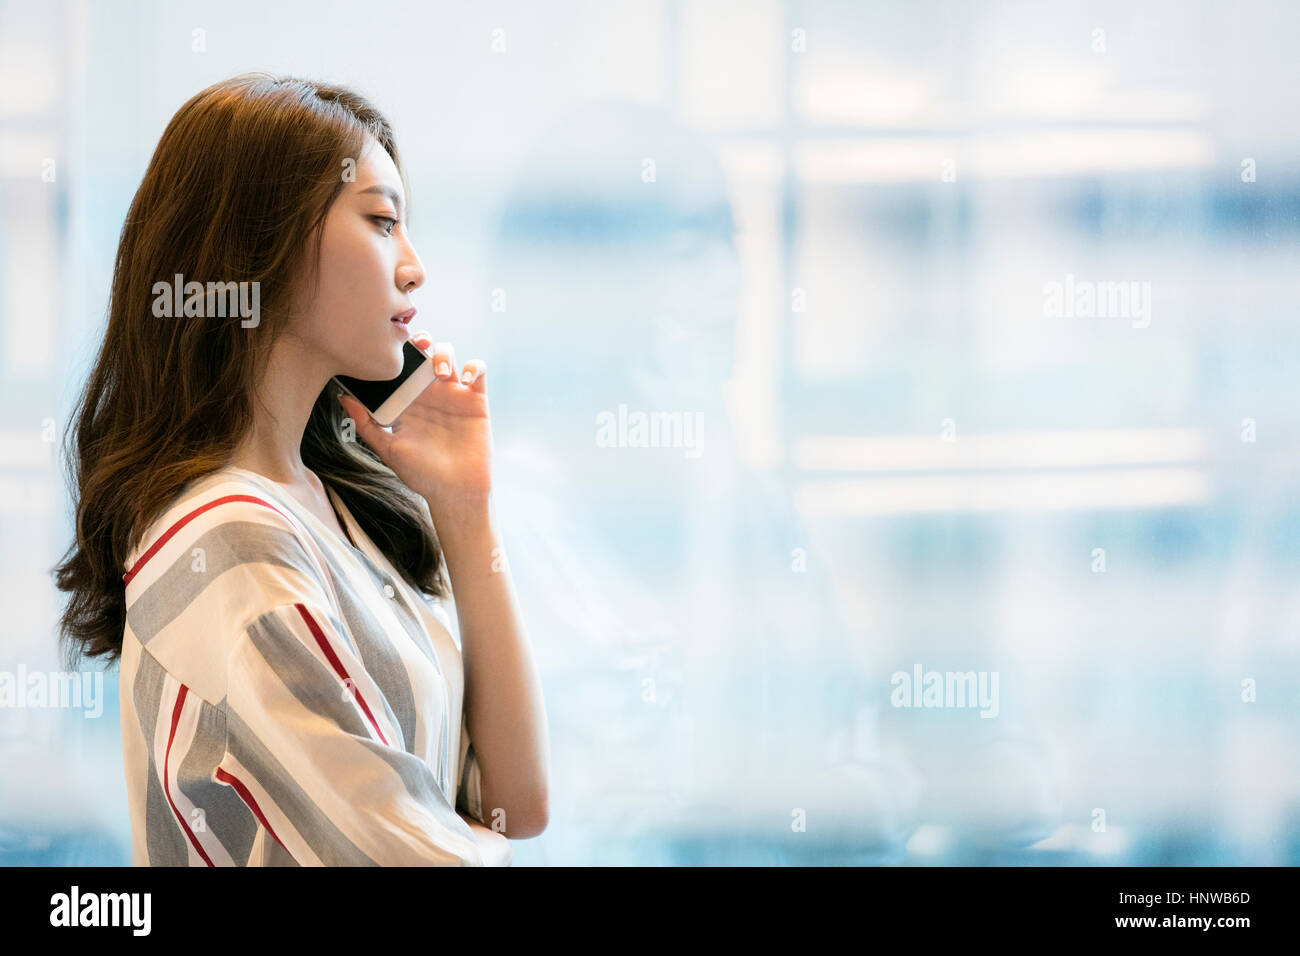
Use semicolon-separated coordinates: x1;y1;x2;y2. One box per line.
294;137;424;380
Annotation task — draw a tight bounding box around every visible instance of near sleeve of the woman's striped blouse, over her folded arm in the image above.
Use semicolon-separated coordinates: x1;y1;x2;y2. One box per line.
217;596;484;866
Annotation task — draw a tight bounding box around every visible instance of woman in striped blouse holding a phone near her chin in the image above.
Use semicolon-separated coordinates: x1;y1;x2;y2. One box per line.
56;74;549;866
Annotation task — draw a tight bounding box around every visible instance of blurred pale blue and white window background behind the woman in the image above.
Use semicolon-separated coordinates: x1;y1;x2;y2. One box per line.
0;0;1300;865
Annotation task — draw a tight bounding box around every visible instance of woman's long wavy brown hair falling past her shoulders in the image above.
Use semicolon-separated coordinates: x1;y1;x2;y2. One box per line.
52;73;450;666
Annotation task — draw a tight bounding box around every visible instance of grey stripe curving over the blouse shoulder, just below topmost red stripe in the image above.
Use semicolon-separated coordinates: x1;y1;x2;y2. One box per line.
126;522;320;645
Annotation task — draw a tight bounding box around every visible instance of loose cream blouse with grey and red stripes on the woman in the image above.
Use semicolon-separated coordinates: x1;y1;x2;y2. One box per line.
120;466;485;866
